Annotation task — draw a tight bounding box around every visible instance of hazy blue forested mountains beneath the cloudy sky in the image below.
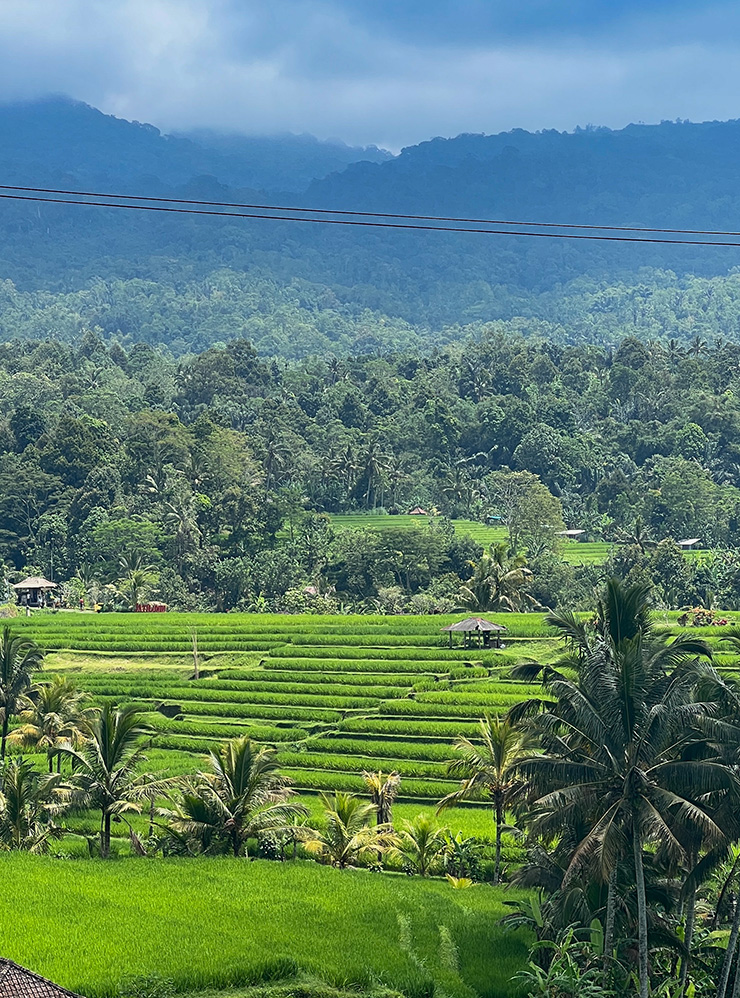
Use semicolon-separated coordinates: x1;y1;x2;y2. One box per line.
0;98;740;357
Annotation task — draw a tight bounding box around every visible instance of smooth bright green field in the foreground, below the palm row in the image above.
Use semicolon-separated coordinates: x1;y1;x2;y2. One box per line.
0;853;528;998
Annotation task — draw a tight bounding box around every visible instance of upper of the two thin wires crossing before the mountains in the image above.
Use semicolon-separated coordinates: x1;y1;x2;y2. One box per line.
0;184;740;239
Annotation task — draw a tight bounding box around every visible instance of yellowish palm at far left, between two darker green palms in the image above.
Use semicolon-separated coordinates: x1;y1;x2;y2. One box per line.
8;676;91;772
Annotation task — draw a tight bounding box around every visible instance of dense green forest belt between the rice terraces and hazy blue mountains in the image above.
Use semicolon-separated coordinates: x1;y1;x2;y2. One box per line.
0;325;740;612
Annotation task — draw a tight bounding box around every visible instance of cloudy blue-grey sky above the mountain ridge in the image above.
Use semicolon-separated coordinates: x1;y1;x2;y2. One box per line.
0;0;740;150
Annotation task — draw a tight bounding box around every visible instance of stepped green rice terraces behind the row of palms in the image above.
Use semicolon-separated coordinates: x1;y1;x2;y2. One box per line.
16;612;737;803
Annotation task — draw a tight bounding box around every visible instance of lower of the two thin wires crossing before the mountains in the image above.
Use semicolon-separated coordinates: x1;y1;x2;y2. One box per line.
0;188;740;248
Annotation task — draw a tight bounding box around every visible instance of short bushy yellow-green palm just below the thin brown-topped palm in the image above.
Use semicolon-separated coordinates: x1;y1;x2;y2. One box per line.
306;791;398;870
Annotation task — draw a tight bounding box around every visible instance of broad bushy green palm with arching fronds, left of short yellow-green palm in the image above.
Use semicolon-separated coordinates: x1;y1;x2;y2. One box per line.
160;735;308;856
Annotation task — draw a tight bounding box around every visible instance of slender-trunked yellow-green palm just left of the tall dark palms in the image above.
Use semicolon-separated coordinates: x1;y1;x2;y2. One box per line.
437;714;530;884
